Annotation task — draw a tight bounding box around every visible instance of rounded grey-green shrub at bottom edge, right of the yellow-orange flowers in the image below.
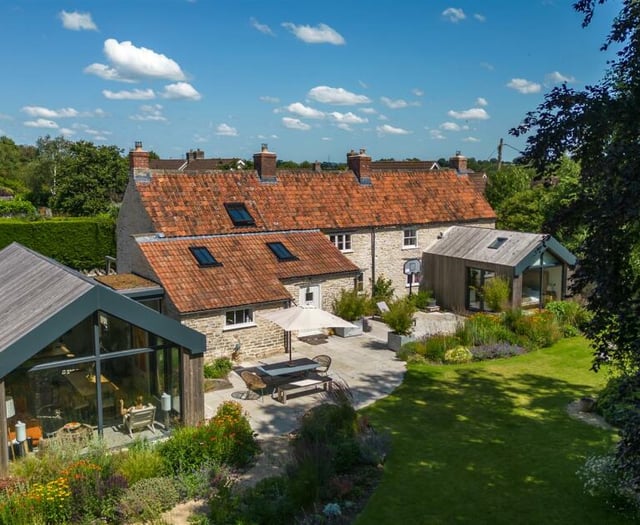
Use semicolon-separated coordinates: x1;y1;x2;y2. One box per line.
118;477;180;523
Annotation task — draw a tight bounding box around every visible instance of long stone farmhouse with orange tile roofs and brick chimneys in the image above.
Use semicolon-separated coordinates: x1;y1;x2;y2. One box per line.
117;143;495;355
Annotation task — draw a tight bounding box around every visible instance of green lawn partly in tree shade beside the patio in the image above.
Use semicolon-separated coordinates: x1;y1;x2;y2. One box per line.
356;338;632;525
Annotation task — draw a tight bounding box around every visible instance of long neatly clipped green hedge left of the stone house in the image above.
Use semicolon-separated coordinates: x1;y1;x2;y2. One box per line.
0;217;116;270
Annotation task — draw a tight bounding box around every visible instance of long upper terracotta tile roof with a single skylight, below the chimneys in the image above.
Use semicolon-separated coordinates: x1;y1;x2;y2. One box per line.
137;170;495;236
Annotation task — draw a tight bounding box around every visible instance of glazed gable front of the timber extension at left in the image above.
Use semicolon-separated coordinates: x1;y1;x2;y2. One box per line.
5;313;180;448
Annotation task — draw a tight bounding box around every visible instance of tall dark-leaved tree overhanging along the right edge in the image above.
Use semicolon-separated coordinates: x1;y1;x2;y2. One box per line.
512;0;640;370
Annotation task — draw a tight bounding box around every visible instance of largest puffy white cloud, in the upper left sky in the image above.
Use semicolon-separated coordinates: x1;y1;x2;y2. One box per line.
84;38;185;82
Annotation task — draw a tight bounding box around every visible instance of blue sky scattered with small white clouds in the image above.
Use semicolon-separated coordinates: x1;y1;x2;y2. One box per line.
0;0;619;162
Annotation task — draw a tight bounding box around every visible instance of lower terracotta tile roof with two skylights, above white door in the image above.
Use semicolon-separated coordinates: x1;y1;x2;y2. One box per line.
137;231;359;313
